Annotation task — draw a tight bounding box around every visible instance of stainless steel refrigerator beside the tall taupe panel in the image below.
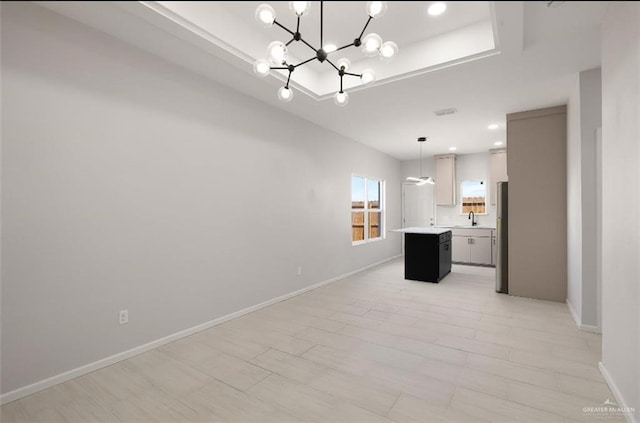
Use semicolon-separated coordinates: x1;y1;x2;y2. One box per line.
496;182;509;294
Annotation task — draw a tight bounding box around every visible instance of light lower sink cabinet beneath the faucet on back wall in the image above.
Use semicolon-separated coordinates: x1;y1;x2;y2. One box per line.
451;229;493;265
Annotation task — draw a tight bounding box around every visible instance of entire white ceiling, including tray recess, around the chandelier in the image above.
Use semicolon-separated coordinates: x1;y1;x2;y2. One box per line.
38;1;607;160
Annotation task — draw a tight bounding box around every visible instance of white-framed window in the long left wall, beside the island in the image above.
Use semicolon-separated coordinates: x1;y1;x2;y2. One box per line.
351;175;384;244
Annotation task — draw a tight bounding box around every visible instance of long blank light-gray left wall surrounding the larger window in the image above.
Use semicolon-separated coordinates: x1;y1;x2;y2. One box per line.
1;2;401;393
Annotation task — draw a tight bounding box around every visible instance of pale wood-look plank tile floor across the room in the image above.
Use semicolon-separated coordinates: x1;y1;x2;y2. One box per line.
1;259;624;423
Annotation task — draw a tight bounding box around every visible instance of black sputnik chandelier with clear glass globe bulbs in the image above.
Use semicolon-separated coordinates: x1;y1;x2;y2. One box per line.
253;1;398;106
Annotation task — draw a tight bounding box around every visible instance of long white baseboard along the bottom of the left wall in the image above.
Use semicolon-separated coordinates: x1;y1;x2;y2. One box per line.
0;255;401;405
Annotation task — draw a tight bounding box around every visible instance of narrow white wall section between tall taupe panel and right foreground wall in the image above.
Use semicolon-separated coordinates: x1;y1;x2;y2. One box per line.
567;68;602;331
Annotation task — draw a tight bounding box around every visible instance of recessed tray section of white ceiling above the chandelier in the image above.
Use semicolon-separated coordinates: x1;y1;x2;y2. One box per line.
152;1;498;100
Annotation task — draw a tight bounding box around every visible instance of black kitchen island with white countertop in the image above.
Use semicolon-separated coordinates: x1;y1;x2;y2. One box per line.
395;228;451;283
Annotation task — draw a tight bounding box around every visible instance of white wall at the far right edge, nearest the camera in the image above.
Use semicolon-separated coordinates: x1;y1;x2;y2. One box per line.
602;2;640;421
